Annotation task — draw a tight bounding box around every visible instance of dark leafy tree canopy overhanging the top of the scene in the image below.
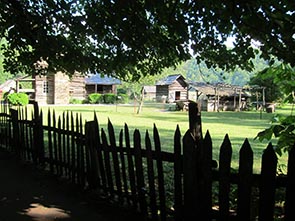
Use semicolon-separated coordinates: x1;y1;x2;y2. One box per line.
0;0;295;80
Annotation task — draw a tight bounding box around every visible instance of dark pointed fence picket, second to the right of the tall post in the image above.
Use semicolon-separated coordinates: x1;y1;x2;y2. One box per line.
218;134;232;220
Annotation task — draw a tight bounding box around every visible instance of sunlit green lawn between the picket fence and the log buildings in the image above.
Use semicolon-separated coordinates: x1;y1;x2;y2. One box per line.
37;104;291;172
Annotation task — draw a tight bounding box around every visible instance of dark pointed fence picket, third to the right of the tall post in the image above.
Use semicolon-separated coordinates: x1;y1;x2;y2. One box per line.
237;139;253;221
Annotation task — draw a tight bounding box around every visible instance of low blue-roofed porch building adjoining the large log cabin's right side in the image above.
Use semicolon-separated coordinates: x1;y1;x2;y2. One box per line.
85;74;121;95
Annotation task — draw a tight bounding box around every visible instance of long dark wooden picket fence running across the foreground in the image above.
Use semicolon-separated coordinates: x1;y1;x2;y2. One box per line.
0;103;295;221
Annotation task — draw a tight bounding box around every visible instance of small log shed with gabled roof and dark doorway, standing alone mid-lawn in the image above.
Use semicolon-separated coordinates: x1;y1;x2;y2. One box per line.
156;74;188;103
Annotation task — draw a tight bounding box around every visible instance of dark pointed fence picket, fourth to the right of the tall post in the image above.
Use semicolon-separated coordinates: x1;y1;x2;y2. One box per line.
259;144;277;221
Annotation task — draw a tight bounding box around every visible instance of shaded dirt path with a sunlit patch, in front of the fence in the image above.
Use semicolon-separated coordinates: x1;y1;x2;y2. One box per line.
0;149;140;221
